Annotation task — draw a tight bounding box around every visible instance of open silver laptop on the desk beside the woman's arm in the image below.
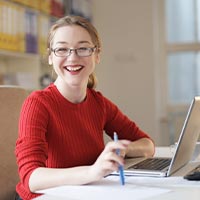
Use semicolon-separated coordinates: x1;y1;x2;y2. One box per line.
124;96;200;177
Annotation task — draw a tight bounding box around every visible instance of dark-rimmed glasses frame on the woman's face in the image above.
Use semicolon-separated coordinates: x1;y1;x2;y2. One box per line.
51;46;97;57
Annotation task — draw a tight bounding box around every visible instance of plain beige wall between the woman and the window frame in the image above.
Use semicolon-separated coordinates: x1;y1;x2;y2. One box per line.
93;0;160;144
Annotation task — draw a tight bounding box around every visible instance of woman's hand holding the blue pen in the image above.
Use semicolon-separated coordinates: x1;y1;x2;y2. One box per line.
90;140;130;180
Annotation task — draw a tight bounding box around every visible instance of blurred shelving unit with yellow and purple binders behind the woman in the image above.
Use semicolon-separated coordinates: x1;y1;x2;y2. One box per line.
0;0;68;90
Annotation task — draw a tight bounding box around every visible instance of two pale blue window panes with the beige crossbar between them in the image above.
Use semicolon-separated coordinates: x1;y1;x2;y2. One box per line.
165;0;200;105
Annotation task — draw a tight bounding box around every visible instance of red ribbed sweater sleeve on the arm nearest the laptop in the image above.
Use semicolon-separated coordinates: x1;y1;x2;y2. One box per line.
101;97;150;141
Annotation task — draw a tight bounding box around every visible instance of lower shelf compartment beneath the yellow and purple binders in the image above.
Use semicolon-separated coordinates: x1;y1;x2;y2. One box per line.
0;50;41;90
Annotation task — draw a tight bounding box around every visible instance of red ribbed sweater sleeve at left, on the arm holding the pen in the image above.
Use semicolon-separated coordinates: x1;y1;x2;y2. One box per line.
15;94;48;190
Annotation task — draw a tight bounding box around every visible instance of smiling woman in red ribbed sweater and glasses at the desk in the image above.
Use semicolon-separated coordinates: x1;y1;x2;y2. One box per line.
16;16;154;200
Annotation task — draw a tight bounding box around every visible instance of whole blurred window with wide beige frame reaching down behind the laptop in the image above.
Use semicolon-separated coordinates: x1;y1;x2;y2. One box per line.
157;0;200;144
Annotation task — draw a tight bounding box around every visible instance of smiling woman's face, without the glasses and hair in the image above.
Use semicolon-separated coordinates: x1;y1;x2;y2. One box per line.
49;25;99;86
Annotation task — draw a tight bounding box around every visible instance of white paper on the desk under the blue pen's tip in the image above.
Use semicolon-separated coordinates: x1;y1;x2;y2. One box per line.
38;176;170;200
